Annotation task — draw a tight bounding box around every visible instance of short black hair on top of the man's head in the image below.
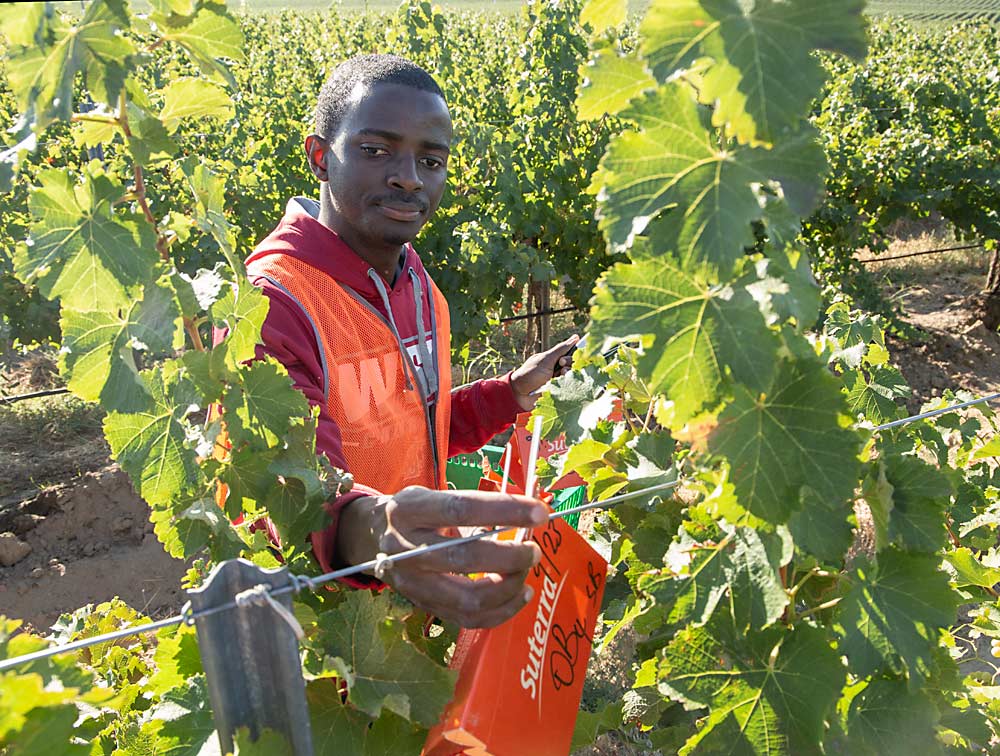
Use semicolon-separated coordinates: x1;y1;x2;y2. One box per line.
316;55;444;139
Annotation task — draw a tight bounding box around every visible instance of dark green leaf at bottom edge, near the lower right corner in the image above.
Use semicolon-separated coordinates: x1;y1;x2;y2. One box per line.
847;680;940;756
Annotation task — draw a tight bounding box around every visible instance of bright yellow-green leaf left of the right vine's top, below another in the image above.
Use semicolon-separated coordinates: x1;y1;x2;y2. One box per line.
576;43;656;120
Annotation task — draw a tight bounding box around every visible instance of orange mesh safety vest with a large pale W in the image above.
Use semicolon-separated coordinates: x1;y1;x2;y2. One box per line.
247;254;451;494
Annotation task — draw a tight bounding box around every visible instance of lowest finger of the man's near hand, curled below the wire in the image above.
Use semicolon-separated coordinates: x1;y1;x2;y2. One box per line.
394;571;533;627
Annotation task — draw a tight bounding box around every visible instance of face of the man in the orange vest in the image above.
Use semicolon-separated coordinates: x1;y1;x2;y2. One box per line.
307;84;452;253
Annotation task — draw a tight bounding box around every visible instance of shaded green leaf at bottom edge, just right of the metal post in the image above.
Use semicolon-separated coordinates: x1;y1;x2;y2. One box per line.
306;680;427;756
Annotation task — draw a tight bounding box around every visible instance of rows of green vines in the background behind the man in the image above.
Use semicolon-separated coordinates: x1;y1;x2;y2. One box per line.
7;3;1000;349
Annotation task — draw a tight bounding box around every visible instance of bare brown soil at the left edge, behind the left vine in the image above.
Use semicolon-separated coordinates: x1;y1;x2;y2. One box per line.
0;352;185;632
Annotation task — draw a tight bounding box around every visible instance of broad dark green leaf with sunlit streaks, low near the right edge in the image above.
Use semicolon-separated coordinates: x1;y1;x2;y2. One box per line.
838;547;959;678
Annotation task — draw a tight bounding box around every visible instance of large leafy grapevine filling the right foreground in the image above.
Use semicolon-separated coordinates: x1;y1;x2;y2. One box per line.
548;0;997;754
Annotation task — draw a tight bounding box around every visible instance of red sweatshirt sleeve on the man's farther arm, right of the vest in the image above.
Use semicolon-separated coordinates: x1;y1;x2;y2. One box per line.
448;373;524;456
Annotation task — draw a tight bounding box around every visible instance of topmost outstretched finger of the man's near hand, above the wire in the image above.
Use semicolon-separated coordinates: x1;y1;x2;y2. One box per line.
386;488;548;531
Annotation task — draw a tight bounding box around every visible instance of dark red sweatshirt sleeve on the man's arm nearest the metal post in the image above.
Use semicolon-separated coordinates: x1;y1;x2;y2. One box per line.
248;279;381;588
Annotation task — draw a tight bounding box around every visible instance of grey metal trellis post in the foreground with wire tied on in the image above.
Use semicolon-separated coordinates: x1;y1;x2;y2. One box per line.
188;559;313;756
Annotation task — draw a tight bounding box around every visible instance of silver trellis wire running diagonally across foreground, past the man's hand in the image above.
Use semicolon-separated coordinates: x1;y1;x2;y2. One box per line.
0;393;1000;672
